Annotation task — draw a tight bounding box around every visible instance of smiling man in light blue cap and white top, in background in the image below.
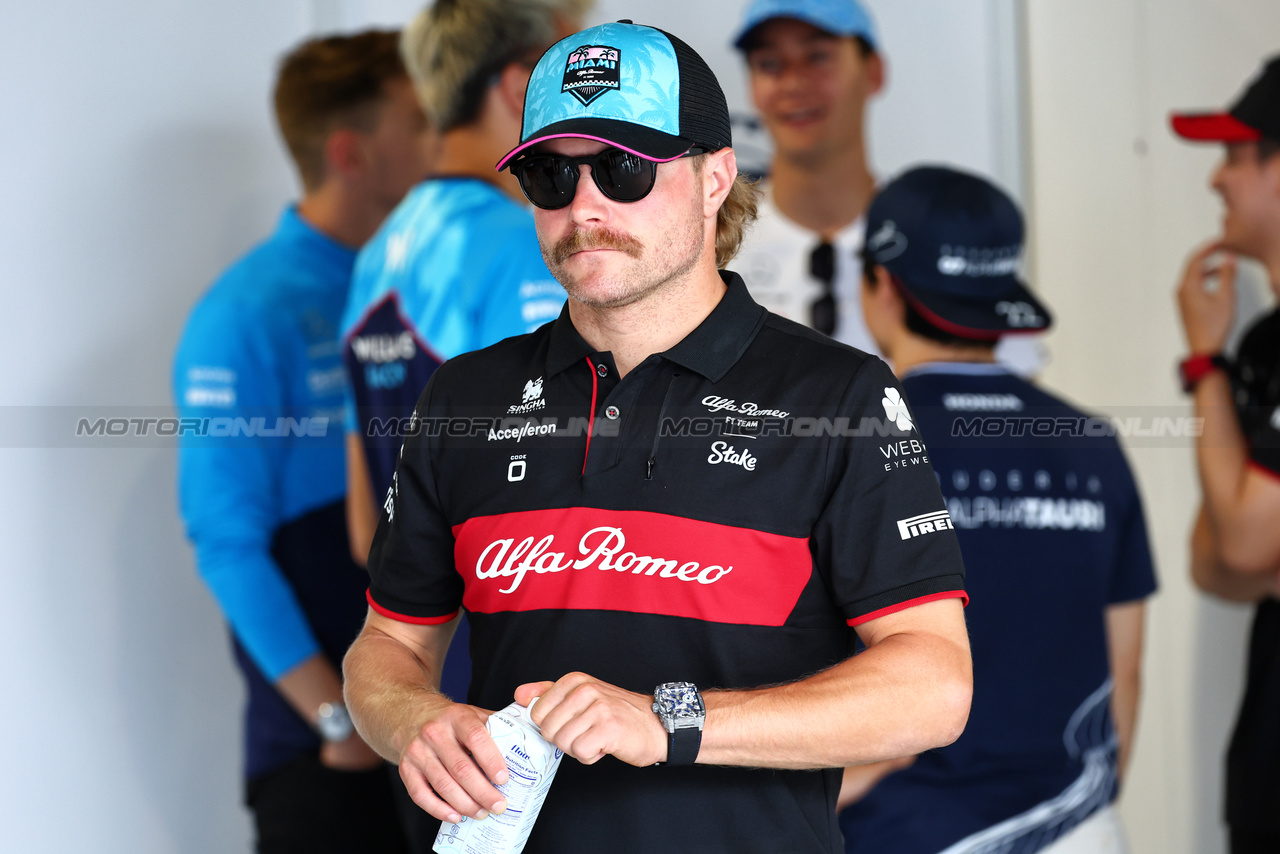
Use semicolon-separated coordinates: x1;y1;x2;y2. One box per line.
733;0;1044;375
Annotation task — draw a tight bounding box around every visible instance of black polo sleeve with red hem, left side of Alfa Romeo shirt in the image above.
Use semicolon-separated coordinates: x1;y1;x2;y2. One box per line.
369;378;463;625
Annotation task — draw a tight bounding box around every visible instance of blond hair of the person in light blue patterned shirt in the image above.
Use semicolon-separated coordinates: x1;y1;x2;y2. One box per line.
401;0;594;132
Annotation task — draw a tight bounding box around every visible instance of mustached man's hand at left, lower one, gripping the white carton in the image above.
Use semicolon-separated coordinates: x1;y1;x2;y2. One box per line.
399;703;507;822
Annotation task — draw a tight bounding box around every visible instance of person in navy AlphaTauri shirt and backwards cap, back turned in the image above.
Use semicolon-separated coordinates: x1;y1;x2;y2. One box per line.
841;166;1156;854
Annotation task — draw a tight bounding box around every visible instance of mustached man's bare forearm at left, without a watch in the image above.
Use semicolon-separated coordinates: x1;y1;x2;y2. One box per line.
343;614;453;762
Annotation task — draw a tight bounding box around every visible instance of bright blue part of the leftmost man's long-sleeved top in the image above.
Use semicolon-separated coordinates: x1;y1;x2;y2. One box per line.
173;207;362;681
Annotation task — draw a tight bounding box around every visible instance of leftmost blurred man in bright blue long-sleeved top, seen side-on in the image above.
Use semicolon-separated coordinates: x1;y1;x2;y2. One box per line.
173;31;430;853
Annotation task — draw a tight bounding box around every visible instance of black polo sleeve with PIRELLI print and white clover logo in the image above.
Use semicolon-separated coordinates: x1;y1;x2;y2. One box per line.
813;359;966;626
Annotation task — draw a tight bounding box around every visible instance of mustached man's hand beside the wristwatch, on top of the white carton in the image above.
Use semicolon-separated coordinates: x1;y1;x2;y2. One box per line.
516;673;667;766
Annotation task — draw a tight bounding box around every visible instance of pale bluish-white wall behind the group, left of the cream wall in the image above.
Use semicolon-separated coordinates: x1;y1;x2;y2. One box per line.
0;0;1020;854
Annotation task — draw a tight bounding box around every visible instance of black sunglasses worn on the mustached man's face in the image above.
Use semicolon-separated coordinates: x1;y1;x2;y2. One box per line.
511;147;703;210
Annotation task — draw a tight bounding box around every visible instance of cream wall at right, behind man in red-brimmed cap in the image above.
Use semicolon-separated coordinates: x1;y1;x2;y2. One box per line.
1027;0;1280;854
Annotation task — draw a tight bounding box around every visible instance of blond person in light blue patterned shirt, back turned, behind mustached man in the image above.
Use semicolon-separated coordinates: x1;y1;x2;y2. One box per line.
332;6;591;752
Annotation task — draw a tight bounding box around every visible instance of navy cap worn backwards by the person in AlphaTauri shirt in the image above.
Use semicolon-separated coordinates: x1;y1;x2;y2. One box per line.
863;166;1052;341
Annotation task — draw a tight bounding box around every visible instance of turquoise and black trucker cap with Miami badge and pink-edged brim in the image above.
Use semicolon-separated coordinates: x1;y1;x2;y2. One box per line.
498;20;733;172
